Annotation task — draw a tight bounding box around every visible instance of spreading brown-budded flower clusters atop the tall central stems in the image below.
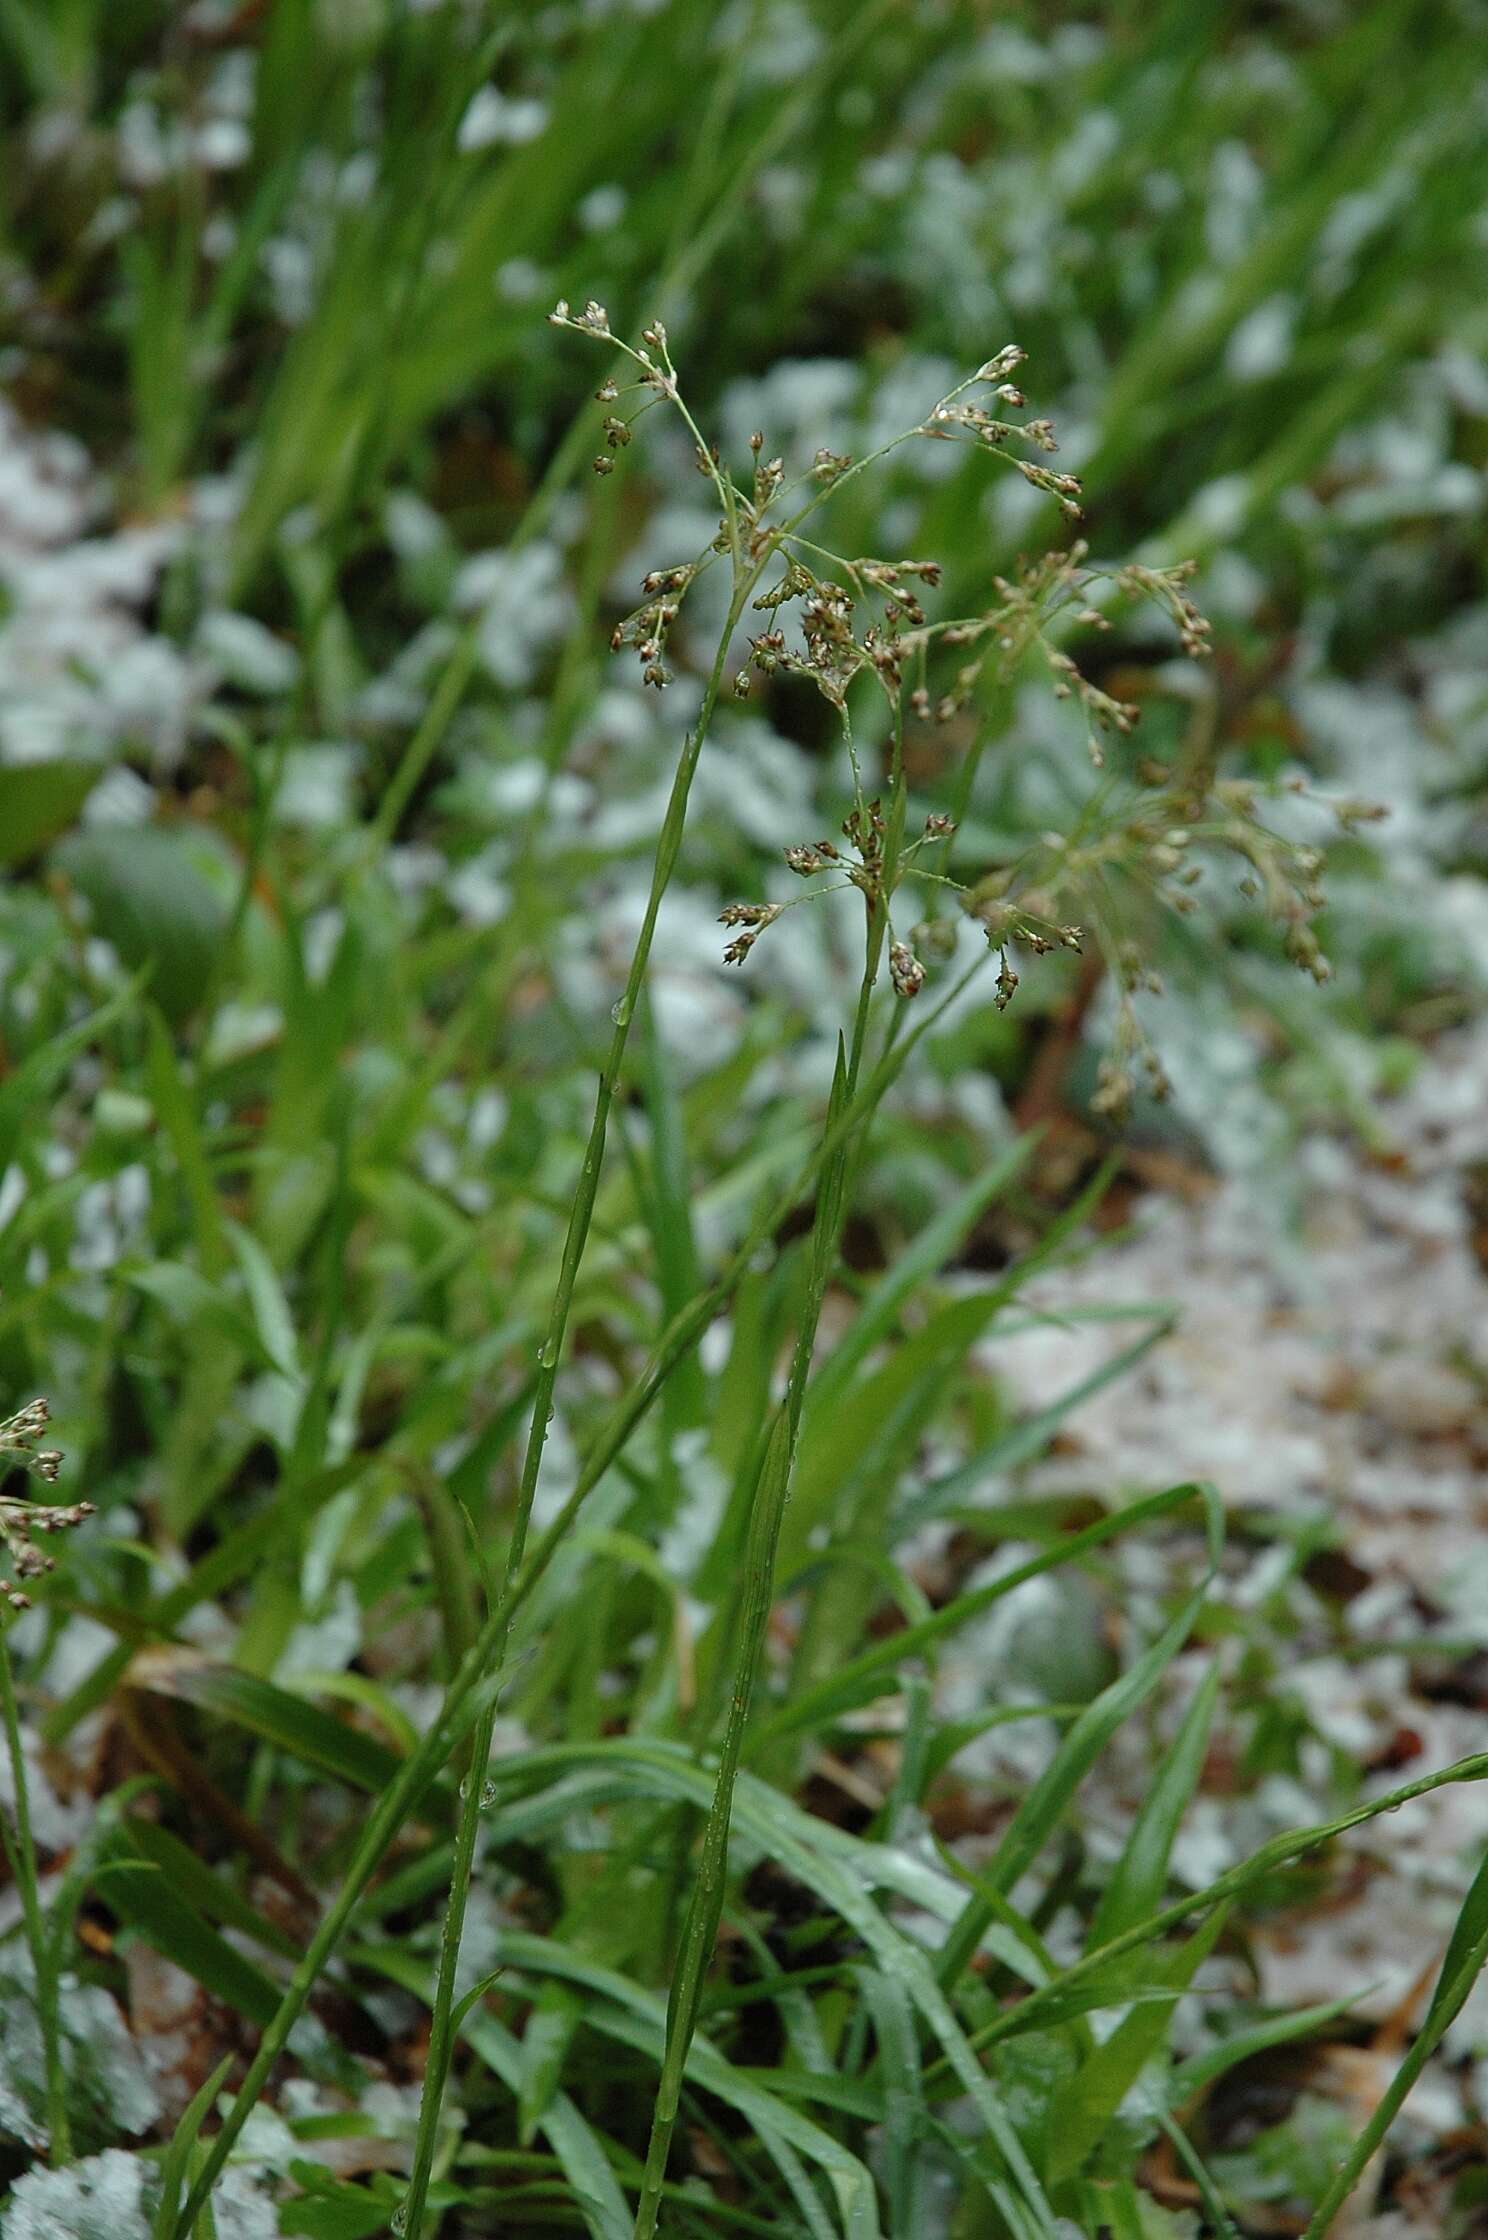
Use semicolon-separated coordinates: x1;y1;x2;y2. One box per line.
554;302;1374;1116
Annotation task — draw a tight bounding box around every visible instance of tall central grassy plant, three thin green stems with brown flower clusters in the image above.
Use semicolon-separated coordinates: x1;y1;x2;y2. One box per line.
175;302;1380;2240
